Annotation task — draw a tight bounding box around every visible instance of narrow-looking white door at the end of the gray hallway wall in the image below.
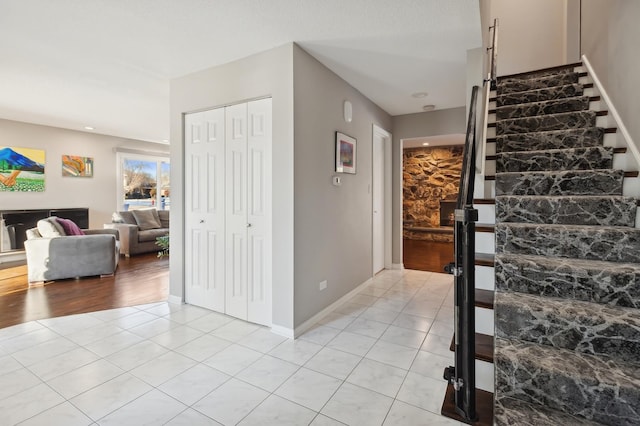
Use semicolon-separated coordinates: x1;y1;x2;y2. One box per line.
372;131;385;275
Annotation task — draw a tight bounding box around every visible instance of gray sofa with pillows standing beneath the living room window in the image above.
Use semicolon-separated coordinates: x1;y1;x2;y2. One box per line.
105;209;169;257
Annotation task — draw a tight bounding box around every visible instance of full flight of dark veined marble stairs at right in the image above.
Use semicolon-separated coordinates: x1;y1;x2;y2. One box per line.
493;64;640;426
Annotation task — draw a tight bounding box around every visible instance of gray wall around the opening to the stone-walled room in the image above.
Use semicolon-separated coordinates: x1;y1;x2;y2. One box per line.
392;107;467;263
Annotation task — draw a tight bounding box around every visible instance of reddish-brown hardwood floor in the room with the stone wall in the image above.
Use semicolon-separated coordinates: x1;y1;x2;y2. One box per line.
403;238;453;273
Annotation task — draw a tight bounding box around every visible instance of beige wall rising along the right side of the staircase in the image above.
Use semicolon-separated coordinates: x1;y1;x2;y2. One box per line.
581;0;640;148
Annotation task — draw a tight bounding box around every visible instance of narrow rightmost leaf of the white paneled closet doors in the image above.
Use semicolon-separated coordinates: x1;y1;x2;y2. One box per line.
247;99;272;325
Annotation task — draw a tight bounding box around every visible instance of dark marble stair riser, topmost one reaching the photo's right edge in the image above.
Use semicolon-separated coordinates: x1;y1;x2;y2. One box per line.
496;222;640;263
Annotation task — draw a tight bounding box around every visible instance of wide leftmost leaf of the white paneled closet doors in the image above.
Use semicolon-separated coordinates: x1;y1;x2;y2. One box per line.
185;108;225;312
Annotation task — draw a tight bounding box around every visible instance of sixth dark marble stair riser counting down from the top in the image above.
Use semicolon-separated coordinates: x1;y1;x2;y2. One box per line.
496;146;613;173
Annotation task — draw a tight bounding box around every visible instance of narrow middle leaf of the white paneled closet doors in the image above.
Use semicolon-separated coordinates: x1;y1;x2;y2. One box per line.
225;104;250;320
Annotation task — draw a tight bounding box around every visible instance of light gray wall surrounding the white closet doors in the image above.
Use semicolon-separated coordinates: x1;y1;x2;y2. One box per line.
170;44;294;328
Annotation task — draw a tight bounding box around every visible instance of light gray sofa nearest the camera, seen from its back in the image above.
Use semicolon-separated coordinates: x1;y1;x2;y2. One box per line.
24;217;120;284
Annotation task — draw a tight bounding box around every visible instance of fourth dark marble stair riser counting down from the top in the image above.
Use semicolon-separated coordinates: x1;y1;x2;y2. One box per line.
496;111;596;135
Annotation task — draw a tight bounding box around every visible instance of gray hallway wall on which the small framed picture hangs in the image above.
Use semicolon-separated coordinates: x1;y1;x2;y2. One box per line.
293;46;391;326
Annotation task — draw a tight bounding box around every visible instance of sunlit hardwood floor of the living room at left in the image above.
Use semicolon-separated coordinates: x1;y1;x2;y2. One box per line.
0;253;169;328
